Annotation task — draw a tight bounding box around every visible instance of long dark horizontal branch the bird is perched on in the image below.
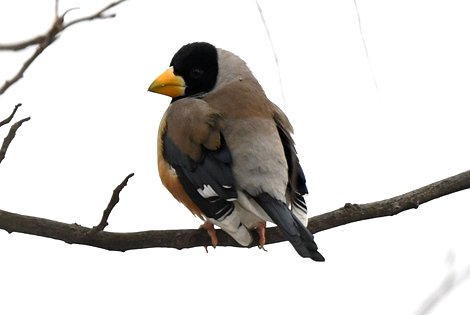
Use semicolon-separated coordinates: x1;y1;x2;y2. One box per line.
0;171;470;251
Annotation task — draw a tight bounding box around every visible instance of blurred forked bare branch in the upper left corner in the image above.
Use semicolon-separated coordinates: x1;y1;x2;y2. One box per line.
0;0;126;95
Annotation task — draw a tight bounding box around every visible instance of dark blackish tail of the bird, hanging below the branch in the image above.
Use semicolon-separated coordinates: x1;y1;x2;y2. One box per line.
254;193;325;261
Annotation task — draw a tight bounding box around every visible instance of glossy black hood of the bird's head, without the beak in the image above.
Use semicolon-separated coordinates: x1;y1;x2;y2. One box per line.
170;42;219;96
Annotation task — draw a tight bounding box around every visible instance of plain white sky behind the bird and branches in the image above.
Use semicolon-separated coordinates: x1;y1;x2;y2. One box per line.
0;0;470;314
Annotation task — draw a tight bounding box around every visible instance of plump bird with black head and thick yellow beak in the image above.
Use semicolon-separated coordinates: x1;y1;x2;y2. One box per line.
148;42;325;261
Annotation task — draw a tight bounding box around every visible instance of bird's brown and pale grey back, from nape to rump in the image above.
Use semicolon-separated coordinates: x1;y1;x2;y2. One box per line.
203;49;288;201
